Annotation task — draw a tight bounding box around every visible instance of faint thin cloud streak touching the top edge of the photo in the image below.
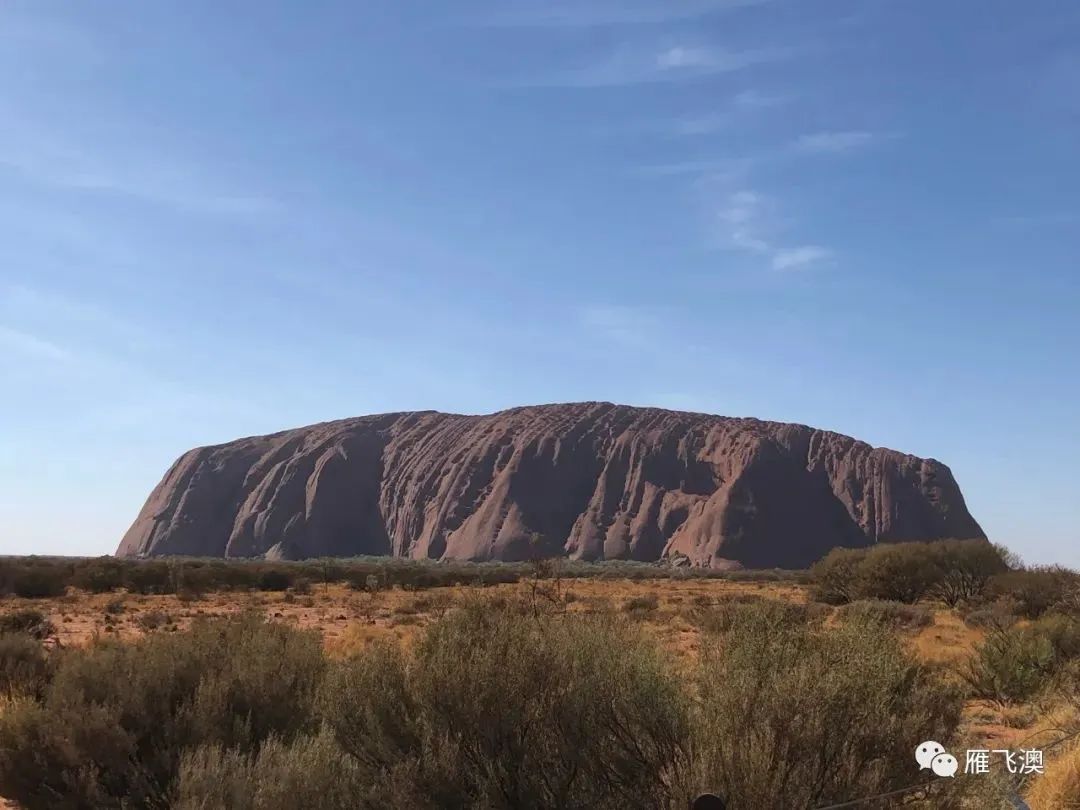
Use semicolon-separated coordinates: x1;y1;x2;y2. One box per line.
485;0;771;28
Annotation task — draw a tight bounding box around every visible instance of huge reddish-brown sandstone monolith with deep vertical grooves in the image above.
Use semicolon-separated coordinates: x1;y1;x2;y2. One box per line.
117;403;984;567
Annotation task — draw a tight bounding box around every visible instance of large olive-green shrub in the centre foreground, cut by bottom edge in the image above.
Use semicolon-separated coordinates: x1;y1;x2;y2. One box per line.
324;605;688;810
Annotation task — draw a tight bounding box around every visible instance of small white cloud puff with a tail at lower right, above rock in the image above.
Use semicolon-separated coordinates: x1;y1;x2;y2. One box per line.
713;189;833;270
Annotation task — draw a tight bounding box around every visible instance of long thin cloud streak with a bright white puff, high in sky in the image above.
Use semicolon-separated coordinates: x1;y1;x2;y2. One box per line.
512;45;789;87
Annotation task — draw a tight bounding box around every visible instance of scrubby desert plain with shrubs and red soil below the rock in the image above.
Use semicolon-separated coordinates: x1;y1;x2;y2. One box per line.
0;543;1080;810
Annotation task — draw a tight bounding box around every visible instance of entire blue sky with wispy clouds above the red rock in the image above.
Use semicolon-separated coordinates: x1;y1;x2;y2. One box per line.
0;0;1080;565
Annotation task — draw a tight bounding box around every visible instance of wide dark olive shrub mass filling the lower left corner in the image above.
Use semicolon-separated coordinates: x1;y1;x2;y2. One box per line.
0;616;324;810
